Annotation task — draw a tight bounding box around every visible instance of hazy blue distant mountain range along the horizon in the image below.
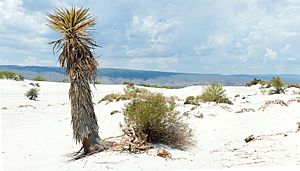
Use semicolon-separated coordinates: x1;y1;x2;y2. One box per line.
0;65;300;87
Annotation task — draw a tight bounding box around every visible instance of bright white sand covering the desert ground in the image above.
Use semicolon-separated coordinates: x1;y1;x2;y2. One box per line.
0;80;300;171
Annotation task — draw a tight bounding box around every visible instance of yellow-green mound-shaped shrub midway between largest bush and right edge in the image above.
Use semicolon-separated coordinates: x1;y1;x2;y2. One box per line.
197;83;232;104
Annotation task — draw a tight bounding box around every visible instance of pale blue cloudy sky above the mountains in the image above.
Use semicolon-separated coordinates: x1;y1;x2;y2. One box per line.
0;0;300;74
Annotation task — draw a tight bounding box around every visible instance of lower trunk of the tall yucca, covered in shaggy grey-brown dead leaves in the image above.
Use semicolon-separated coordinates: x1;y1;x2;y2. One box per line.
69;73;100;153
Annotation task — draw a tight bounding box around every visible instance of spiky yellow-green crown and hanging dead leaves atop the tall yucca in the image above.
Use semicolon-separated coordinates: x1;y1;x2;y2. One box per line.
48;6;98;83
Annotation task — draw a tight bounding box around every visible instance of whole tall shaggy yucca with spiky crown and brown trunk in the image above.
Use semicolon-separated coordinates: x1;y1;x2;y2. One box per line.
48;6;104;154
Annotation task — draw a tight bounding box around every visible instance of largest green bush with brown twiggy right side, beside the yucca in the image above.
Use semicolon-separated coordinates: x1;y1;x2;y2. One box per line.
124;93;193;150
